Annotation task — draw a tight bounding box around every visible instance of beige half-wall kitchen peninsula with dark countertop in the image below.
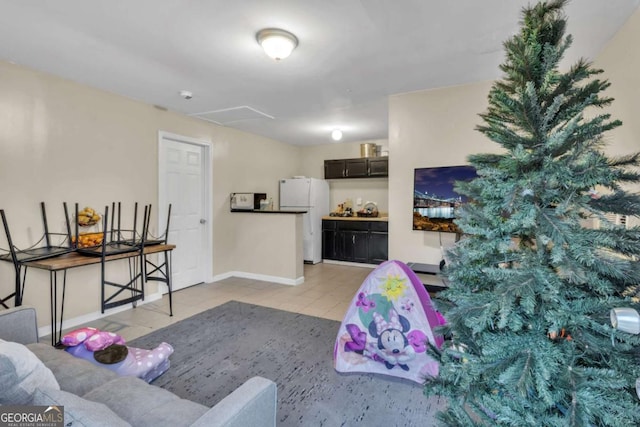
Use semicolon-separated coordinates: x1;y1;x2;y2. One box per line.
228;210;306;285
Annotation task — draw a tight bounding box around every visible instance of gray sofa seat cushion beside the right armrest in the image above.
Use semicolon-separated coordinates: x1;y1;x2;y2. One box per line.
83;377;209;427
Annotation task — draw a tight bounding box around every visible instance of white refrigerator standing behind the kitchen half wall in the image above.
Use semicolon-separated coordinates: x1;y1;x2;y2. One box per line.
280;178;331;264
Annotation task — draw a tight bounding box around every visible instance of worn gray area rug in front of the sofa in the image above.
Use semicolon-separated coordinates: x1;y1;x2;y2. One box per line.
128;301;444;427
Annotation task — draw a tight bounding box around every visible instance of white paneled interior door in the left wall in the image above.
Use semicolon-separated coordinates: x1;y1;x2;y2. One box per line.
158;133;211;290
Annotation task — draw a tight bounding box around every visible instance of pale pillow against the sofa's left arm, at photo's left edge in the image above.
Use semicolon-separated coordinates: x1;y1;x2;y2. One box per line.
0;340;60;405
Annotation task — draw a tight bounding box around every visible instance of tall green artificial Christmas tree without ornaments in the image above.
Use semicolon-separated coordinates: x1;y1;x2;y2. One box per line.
425;0;640;427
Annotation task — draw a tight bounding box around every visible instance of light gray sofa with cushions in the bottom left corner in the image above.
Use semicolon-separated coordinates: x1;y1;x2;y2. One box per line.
0;307;277;427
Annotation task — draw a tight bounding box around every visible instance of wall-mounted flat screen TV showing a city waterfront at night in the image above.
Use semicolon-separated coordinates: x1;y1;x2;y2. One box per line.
413;166;477;233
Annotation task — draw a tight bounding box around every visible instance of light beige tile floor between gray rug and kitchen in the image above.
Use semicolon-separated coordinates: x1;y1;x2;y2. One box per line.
62;263;372;342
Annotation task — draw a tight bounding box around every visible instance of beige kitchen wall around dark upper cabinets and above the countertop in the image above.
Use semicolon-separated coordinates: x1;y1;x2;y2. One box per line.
301;139;389;212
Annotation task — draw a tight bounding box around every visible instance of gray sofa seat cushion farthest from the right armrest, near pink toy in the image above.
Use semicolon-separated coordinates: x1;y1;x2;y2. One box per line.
27;344;118;396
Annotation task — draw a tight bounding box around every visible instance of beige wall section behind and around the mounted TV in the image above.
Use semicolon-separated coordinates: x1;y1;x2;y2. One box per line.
389;82;497;264
